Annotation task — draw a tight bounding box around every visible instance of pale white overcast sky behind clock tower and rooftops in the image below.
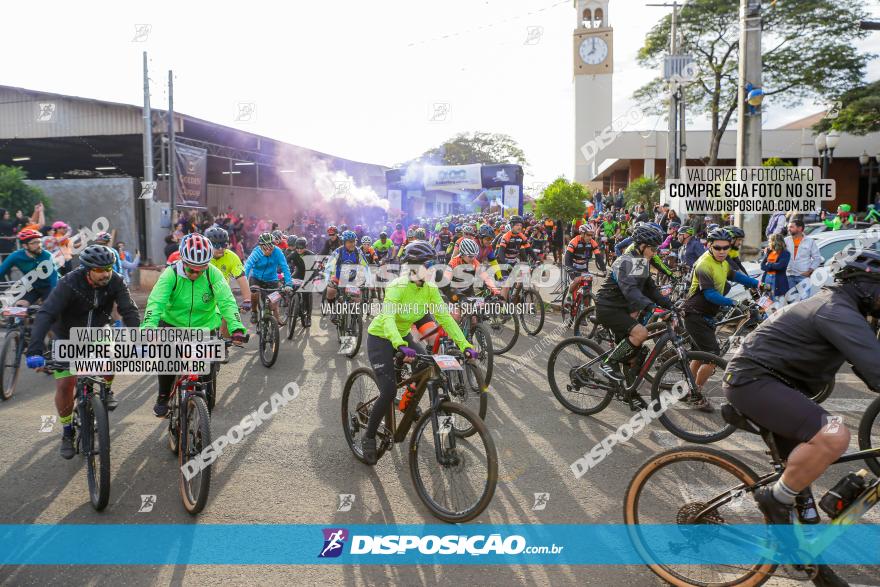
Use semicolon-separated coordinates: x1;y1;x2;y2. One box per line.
0;0;880;183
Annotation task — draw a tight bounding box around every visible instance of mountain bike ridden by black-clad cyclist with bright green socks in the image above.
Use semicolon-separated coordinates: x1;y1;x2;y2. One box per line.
547;310;734;443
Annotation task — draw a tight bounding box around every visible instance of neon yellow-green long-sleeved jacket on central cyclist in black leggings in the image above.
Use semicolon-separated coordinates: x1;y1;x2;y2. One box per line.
367;276;471;350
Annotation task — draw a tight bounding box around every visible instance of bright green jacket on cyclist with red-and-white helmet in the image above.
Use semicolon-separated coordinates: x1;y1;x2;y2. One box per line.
141;261;247;332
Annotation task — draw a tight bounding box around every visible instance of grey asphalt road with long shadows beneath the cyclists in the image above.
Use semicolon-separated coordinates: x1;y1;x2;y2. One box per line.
0;288;880;587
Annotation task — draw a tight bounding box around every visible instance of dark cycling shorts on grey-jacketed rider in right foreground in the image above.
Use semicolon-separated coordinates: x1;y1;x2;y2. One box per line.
721;374;829;442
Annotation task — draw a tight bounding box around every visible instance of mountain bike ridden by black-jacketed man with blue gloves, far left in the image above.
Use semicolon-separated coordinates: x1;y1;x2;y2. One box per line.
42;353;110;512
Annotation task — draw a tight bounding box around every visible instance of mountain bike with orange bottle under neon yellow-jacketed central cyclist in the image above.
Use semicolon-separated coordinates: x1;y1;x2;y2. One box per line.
342;353;498;523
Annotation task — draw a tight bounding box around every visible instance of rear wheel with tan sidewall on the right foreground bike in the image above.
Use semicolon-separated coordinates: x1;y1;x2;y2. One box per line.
623;446;776;587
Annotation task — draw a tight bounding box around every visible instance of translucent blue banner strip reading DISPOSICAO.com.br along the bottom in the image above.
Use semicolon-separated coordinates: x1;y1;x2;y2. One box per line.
0;524;880;565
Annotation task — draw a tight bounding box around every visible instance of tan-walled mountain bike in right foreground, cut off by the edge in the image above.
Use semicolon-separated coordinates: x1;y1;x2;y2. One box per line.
624;398;880;586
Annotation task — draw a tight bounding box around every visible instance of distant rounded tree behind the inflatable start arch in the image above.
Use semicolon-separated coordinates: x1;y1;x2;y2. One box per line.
417;132;528;167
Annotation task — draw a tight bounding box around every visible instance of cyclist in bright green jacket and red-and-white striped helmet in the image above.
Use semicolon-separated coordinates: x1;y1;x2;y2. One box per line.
141;233;248;418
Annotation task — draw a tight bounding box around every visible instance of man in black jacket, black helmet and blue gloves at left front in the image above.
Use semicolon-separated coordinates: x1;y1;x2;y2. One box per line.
25;245;140;459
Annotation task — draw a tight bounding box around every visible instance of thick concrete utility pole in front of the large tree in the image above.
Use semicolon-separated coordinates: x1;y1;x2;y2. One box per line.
736;0;763;252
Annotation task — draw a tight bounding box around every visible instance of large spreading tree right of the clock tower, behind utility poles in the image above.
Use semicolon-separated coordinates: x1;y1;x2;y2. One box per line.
634;0;874;165
